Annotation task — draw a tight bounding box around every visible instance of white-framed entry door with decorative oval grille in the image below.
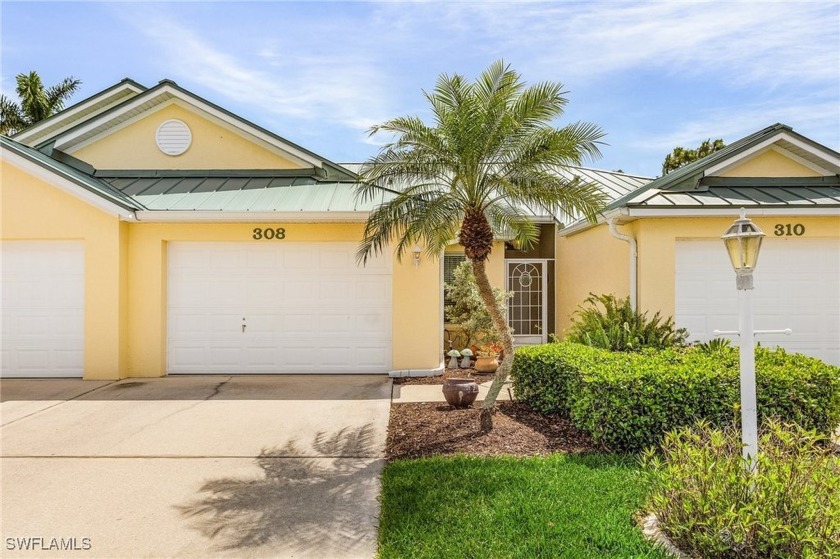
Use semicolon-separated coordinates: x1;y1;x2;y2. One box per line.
505;260;548;346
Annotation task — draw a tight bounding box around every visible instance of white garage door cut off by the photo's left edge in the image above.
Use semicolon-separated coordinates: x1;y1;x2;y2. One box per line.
0;241;85;377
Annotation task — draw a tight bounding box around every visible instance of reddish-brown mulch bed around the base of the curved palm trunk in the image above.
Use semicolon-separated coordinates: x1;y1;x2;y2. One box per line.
385;402;597;461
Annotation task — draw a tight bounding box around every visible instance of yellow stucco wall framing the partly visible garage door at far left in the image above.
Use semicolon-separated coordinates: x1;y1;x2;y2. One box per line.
0;160;128;379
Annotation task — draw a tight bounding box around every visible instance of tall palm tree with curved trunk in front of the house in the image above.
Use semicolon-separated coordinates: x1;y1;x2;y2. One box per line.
357;61;604;431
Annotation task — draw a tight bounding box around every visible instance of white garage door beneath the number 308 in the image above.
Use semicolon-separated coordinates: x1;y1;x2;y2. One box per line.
168;242;391;374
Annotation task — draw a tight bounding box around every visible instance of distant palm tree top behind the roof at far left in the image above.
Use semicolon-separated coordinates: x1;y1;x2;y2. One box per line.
0;70;82;135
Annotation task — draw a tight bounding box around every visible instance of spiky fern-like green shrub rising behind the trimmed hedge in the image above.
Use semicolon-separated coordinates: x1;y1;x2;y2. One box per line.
566;293;688;351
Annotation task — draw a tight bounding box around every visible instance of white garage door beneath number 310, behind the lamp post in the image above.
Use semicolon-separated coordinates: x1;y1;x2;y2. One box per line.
676;237;840;365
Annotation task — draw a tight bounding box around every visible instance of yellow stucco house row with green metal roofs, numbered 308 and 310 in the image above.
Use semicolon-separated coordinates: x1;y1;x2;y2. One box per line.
0;80;840;379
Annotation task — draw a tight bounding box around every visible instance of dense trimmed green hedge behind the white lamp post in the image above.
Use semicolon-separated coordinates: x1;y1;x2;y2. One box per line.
511;342;840;451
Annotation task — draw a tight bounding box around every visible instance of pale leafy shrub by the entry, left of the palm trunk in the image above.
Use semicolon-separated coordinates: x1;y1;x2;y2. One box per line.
443;260;510;349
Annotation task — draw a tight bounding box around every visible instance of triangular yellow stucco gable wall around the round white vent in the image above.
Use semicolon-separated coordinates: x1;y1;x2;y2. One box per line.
70;104;300;169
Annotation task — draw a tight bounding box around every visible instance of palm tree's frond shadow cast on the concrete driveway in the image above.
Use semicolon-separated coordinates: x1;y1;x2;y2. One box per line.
176;424;383;556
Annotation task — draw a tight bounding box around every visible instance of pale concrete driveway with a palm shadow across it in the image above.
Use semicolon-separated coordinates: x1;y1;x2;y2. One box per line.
0;376;391;558
